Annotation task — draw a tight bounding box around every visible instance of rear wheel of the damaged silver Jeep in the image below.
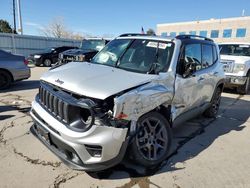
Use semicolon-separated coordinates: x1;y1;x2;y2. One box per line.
204;87;222;118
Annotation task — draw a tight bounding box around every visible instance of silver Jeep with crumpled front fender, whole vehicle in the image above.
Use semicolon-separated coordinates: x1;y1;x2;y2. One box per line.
30;34;224;171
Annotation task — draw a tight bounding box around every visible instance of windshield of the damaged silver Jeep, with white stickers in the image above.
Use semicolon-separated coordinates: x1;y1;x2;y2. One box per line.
92;39;174;74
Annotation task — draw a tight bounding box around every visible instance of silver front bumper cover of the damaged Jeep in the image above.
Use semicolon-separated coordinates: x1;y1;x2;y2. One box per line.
30;101;128;171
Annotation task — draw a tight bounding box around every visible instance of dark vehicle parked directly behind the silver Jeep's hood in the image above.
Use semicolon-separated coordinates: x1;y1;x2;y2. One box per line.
59;38;110;64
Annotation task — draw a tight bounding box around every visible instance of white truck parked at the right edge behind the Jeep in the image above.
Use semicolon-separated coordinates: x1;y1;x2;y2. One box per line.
219;43;250;94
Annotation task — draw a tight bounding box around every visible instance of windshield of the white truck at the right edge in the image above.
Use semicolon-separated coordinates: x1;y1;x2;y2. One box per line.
219;44;250;56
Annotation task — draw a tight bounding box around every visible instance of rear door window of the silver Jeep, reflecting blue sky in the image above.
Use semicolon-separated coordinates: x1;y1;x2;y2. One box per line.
202;44;213;68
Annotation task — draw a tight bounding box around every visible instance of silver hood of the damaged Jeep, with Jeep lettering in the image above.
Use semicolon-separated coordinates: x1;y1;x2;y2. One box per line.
41;62;157;99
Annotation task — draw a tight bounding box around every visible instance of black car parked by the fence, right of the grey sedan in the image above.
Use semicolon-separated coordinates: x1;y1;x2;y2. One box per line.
28;46;77;67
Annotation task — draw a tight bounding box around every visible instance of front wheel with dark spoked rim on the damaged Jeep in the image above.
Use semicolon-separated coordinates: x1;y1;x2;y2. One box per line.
131;112;172;167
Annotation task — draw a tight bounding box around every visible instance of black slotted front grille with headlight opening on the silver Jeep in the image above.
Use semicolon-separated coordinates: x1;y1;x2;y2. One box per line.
36;82;96;132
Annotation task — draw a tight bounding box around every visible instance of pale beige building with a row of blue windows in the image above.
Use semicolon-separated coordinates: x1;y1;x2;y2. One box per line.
157;16;250;42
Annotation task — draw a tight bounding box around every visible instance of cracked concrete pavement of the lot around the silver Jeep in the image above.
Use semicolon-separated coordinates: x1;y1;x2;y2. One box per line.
0;67;250;188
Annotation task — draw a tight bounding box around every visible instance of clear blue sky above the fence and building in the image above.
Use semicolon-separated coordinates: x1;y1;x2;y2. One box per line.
0;0;250;36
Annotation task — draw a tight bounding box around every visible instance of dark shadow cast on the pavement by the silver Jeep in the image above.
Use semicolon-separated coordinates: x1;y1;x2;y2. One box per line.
88;96;250;181
